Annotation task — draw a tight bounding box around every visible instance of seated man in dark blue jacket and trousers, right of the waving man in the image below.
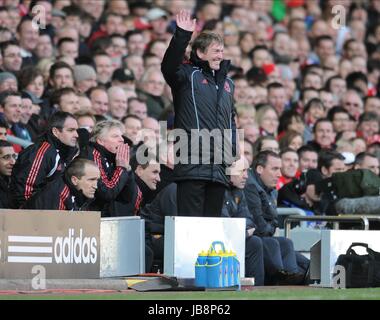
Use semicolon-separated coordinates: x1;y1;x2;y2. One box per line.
244;151;309;284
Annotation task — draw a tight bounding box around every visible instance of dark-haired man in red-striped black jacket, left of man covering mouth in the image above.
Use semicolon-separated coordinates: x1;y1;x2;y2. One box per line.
10;111;78;209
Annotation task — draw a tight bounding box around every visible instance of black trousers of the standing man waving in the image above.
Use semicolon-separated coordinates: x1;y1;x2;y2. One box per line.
177;180;226;217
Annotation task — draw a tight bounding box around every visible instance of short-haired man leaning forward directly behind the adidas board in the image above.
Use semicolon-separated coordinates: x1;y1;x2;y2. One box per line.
24;158;100;211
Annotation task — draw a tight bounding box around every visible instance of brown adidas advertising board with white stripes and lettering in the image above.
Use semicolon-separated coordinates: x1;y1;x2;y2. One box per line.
0;209;100;279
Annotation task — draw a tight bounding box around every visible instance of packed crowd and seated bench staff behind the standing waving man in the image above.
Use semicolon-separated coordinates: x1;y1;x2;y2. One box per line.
0;0;380;284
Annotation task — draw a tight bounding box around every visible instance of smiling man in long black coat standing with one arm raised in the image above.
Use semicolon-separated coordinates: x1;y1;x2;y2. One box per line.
161;11;236;216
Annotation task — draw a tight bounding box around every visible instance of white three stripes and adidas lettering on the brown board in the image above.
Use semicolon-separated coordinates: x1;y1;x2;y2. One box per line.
7;228;98;264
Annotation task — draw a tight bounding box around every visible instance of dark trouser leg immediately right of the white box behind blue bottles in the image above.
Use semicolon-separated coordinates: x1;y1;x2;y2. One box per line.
245;236;264;286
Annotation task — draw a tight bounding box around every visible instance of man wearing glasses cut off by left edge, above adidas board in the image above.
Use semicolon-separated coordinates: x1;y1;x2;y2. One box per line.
0;140;17;208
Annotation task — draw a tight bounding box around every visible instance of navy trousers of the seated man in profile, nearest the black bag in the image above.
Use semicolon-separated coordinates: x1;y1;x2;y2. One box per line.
262;237;300;277
